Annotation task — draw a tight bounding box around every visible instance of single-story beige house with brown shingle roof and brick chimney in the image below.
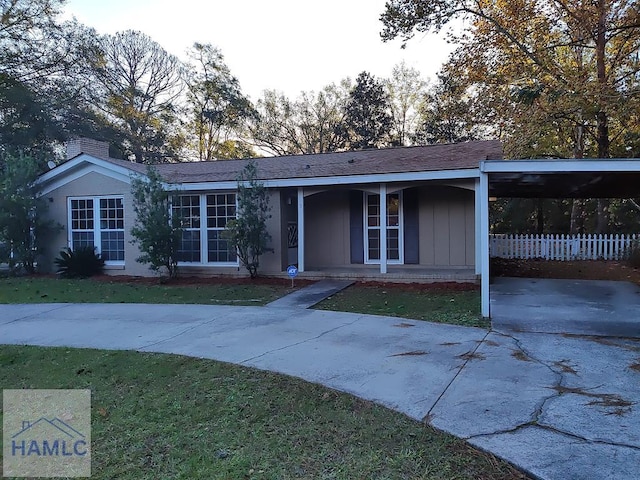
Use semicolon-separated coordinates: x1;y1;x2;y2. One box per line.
40;138;502;281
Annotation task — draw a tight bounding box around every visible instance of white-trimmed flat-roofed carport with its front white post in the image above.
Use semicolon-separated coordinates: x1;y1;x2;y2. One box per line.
476;158;640;317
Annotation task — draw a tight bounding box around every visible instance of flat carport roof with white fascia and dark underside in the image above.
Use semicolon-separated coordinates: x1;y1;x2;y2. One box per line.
480;158;640;198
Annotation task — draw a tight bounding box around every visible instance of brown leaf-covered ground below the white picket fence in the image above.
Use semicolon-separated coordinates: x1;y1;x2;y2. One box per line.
491;258;640;285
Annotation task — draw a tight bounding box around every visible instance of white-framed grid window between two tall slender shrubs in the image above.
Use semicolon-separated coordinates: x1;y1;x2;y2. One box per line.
172;193;238;265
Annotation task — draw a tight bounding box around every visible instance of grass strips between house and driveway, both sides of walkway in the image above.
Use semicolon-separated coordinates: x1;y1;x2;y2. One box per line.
0;276;490;328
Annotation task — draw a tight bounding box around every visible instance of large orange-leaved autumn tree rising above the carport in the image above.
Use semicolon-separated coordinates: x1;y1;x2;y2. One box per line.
381;0;640;232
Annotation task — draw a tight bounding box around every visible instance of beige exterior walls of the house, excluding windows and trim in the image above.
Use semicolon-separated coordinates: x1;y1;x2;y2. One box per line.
42;172;475;275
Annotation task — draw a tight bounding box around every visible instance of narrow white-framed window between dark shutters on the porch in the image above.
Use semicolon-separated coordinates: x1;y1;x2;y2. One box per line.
364;192;403;263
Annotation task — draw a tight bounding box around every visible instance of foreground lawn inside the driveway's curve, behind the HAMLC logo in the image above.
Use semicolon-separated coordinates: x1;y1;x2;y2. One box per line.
0;346;528;480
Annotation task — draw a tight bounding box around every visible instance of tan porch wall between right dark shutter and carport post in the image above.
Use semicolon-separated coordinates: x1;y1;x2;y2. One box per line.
419;186;475;267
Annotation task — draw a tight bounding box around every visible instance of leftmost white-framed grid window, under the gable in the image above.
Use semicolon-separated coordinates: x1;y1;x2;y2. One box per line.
69;197;124;264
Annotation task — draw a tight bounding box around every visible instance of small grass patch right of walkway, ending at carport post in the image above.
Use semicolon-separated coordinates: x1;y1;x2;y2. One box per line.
314;283;484;328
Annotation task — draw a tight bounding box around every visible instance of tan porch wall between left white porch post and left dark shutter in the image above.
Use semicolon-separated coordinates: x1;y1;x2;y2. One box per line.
304;190;351;270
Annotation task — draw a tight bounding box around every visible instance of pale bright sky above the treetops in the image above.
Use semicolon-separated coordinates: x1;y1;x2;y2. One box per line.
66;0;451;100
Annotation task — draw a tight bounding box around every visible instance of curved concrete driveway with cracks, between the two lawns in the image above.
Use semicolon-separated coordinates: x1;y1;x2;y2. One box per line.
0;284;640;480
